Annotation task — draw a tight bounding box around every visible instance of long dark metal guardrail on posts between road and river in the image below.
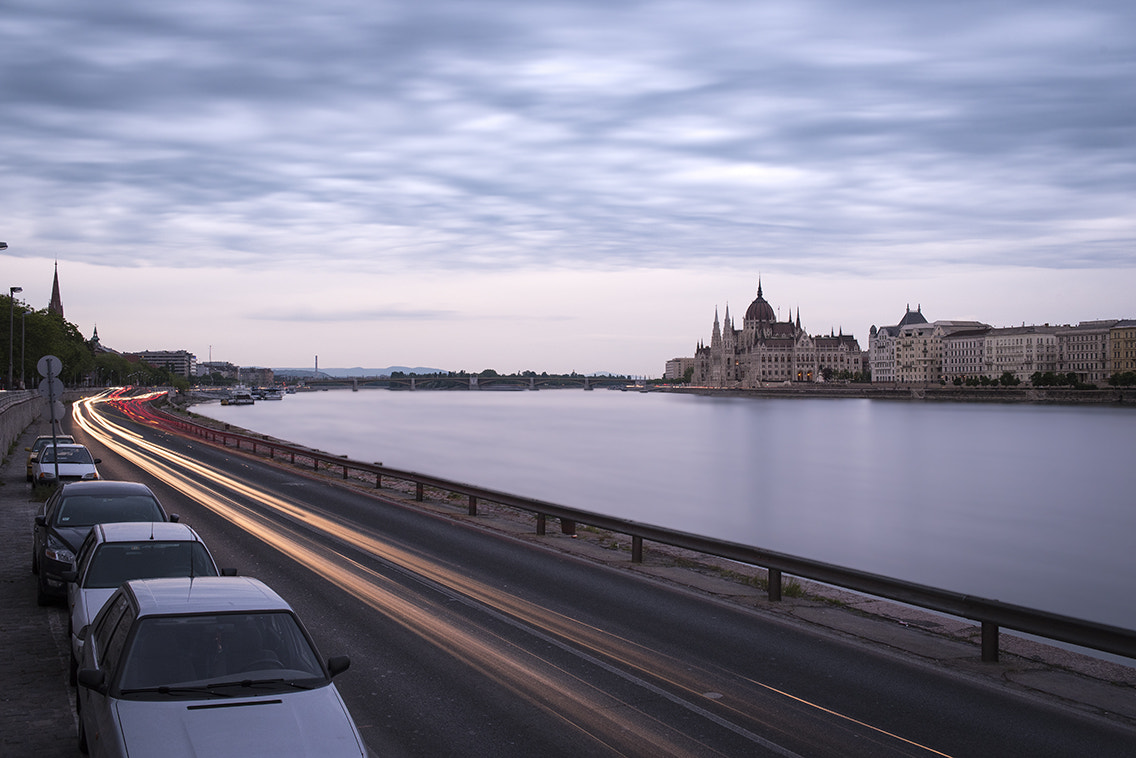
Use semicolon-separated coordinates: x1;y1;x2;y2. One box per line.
154;409;1136;661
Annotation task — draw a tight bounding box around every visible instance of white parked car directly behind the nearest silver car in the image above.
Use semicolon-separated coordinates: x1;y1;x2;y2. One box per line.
62;522;229;684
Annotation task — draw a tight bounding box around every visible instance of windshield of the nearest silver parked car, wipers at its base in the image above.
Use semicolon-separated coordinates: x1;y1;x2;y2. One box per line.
118;611;324;694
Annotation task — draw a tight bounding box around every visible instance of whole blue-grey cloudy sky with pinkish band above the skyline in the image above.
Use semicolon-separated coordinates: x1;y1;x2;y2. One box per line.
0;0;1136;376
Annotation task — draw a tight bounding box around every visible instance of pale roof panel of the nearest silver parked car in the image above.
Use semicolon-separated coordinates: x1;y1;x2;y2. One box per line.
123;576;292;618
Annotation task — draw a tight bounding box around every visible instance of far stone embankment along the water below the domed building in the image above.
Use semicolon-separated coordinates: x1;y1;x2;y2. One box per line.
651;382;1136;407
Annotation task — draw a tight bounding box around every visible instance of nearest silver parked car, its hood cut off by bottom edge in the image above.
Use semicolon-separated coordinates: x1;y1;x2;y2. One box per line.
76;576;367;758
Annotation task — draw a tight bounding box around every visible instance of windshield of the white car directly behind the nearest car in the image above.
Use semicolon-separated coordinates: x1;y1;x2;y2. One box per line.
83;540;217;590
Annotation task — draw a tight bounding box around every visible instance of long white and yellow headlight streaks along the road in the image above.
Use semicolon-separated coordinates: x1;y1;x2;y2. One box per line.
73;395;950;758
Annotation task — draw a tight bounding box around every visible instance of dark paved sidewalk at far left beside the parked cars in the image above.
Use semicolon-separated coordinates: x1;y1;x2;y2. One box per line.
0;422;80;758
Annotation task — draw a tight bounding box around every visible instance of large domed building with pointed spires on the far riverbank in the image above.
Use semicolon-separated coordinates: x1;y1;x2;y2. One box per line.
692;282;863;389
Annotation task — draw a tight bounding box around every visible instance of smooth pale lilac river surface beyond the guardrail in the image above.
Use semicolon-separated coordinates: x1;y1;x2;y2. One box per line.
195;390;1136;628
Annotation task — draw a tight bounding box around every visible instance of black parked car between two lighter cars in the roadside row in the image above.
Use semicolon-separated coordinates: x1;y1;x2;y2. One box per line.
32;480;177;606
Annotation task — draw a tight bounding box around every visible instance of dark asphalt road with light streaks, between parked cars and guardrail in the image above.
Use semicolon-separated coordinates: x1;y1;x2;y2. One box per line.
53;395;1136;757
